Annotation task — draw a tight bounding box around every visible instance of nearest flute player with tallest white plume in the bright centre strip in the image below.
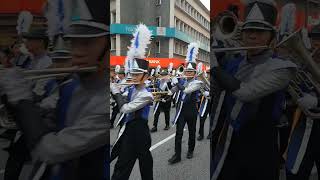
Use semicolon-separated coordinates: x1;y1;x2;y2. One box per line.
110;24;153;180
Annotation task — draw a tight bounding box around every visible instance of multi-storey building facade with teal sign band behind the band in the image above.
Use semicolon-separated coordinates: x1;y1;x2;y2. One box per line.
110;0;210;66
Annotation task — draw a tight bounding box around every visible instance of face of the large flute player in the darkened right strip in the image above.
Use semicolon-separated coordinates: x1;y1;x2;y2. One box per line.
242;29;272;55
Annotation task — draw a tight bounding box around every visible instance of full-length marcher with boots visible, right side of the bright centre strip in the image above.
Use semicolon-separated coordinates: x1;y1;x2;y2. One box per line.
168;43;202;164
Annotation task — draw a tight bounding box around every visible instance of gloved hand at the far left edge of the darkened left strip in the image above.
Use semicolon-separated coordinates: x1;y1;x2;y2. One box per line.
0;68;32;105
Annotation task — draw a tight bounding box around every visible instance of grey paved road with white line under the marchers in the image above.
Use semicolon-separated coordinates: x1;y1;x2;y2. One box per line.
110;109;210;180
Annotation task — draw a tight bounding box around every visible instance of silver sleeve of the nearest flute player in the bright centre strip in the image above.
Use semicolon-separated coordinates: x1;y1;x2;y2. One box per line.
120;92;153;113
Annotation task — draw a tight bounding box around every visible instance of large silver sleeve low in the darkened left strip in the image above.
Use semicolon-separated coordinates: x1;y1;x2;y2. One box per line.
31;99;109;164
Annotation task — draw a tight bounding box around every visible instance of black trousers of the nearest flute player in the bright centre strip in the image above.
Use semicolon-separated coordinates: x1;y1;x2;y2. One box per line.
112;119;153;180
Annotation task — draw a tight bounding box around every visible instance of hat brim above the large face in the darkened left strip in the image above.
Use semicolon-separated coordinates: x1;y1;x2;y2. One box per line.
63;24;110;38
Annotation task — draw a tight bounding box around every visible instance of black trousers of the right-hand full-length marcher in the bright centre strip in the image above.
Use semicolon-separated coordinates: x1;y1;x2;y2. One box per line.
175;111;197;156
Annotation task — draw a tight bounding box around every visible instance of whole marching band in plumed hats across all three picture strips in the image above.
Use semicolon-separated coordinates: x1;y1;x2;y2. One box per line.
0;0;320;180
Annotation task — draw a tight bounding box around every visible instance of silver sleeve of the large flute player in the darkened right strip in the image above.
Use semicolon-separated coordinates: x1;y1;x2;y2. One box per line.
233;68;295;102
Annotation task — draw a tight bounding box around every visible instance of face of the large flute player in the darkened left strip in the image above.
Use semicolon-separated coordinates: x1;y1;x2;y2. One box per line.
71;37;108;67
